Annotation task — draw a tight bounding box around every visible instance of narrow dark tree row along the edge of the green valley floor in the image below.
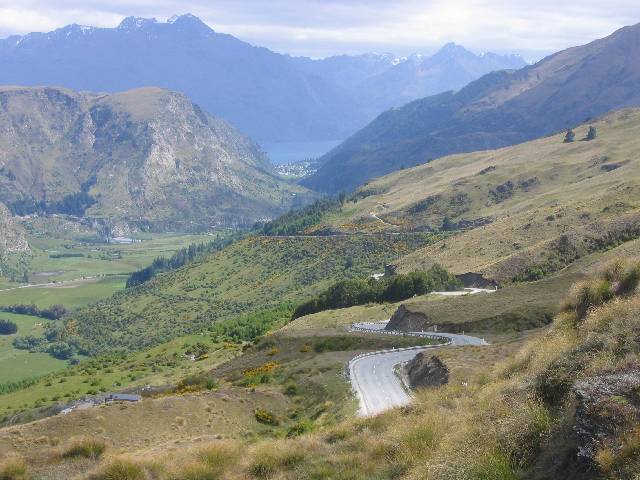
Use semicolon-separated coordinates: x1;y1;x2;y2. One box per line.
127;235;239;288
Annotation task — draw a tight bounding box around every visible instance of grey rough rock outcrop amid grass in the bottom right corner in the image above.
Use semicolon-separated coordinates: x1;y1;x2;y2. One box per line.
574;367;640;462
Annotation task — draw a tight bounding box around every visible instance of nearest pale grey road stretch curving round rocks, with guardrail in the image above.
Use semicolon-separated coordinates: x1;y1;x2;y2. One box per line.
349;322;487;417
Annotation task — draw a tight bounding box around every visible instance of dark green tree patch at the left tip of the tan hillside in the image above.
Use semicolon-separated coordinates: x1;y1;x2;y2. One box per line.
257;194;346;236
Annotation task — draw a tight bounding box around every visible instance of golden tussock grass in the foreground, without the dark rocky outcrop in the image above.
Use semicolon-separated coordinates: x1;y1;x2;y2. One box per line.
74;260;640;480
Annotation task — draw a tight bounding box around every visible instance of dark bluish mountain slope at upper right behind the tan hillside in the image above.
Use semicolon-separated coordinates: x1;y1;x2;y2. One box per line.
303;25;640;192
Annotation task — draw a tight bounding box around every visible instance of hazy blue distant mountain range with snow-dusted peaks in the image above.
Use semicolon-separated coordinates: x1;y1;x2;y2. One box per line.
0;15;524;142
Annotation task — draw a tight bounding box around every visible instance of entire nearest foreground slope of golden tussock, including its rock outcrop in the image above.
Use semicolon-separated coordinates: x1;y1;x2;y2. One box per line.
43;264;640;480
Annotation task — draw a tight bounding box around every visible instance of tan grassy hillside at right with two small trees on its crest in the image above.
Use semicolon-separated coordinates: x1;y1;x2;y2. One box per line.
318;109;640;281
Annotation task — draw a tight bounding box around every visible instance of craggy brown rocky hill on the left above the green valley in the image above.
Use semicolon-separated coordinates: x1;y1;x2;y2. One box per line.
0;87;310;230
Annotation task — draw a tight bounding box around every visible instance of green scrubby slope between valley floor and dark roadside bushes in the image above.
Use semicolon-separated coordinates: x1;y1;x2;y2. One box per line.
68;235;433;352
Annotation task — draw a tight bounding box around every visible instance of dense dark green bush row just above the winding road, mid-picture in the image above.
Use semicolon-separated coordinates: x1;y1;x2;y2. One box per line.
293;265;462;318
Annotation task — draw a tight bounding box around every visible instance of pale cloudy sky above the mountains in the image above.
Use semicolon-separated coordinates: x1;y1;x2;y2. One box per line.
0;0;640;59
